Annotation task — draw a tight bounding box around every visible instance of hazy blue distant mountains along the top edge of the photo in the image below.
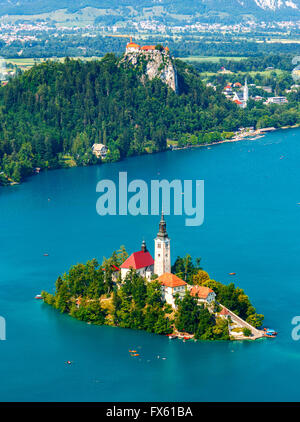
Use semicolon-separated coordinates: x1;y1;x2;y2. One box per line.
0;0;300;21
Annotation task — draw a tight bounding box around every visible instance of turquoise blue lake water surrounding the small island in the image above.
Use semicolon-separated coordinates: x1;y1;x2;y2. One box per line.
0;130;300;401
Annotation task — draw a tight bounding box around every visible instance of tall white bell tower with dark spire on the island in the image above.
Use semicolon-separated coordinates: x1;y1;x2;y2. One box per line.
154;213;171;276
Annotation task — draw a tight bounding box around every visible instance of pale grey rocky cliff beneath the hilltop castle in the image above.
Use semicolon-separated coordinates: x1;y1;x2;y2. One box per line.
122;46;178;93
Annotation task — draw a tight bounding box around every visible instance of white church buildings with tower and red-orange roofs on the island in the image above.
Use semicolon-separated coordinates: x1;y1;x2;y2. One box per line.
120;213;216;308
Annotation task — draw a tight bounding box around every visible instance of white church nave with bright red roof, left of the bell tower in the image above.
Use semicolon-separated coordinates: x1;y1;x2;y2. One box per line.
121;241;154;280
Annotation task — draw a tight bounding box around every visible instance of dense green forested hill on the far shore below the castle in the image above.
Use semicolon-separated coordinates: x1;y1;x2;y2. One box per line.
0;54;299;184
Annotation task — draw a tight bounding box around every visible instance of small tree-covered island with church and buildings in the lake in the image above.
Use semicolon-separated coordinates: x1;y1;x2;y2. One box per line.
41;214;266;341
